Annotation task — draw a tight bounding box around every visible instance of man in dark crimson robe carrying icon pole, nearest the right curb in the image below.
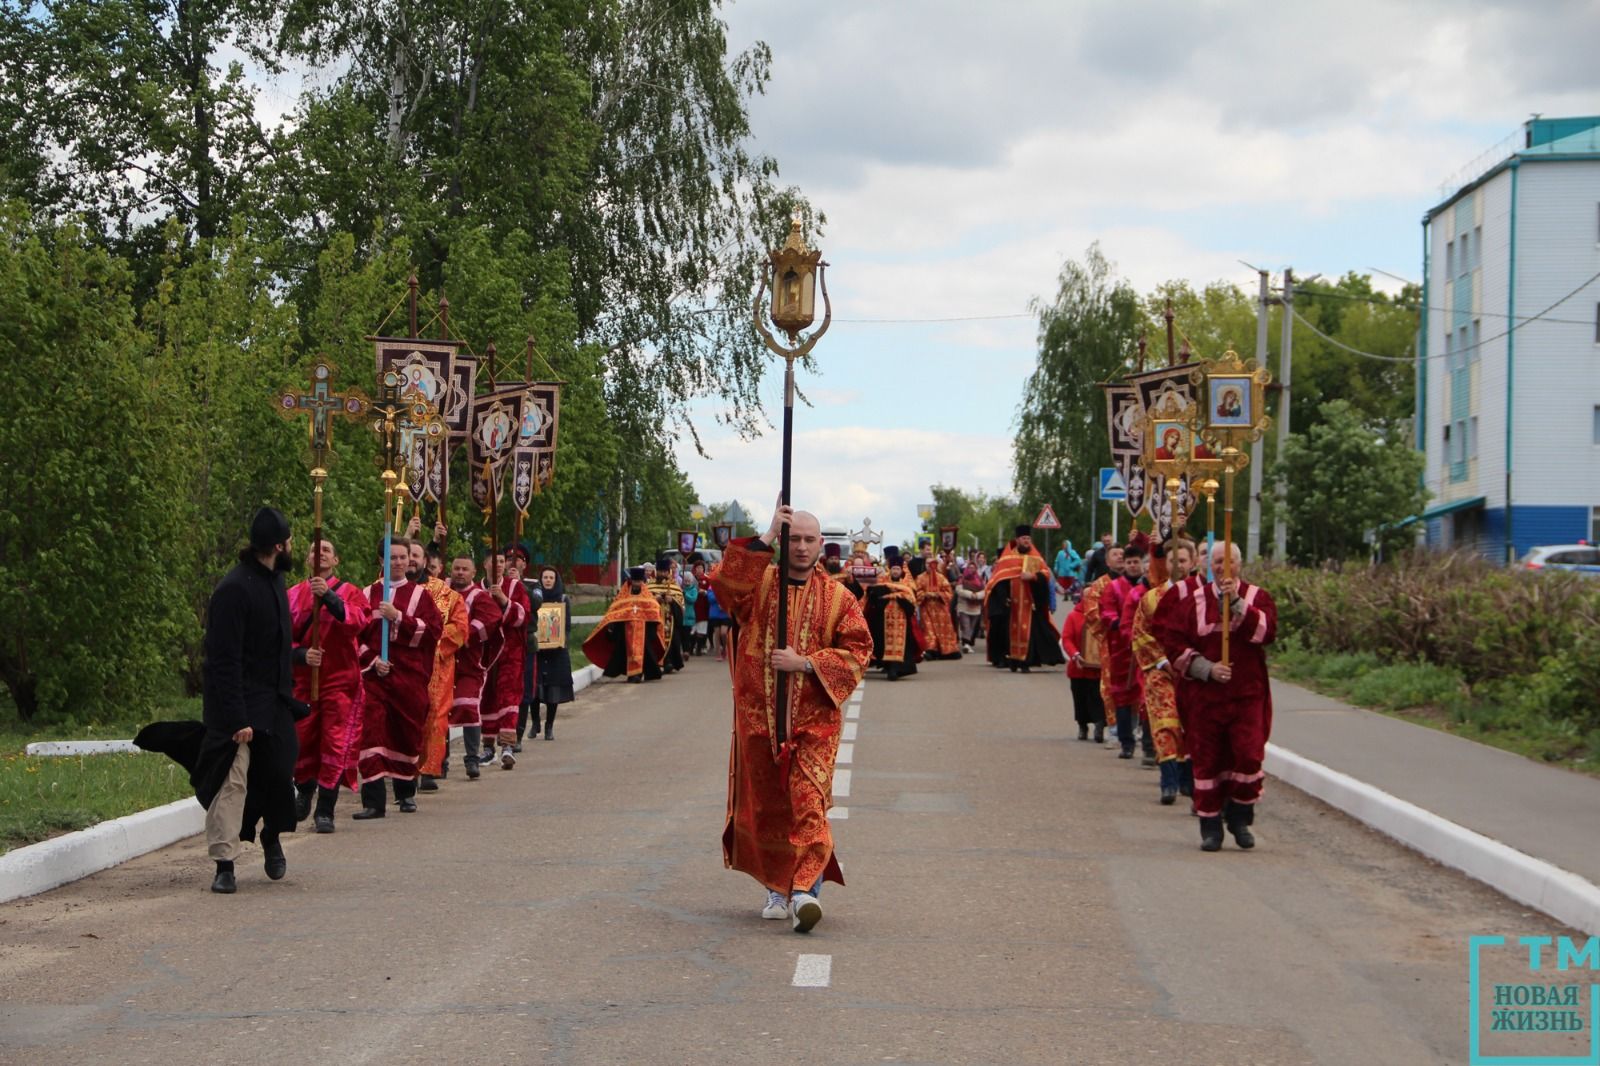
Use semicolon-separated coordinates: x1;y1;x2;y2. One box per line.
1154;541;1278;852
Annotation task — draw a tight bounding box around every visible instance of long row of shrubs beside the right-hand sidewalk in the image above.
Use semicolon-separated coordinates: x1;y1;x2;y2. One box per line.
1253;554;1600;751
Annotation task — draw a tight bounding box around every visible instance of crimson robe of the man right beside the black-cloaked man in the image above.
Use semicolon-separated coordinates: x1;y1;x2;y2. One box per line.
290;578;371;789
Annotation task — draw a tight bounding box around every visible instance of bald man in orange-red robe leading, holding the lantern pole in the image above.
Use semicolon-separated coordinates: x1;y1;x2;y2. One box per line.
712;506;872;933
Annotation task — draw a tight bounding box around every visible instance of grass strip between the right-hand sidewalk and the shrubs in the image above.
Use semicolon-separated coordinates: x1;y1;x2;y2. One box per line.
1272;642;1600;776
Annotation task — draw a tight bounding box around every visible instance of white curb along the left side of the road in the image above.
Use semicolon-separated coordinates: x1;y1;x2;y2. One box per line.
0;664;602;903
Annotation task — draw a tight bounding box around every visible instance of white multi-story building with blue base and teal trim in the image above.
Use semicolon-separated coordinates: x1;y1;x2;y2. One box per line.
1416;117;1600;560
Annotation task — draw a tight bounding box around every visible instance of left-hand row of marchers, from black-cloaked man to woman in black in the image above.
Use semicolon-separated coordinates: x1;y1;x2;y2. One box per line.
136;507;574;893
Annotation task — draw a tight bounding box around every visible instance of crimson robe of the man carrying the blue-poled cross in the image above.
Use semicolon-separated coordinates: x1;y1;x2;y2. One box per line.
355;581;445;784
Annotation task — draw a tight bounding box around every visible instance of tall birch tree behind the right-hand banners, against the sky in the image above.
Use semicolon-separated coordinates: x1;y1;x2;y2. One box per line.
1017;245;1142;535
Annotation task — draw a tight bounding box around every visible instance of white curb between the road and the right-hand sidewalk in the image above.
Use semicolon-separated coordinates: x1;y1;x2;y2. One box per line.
1262;744;1600;936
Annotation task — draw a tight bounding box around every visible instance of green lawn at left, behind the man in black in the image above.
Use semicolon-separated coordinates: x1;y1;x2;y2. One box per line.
0;698;200;853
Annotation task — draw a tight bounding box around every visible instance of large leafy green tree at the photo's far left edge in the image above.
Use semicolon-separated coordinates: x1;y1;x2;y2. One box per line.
0;205;192;719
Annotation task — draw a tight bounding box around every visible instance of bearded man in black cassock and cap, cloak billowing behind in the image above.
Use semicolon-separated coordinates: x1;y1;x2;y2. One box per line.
134;507;307;893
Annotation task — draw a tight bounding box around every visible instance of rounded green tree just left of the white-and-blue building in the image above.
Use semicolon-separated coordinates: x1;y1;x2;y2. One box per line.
1274;400;1427;562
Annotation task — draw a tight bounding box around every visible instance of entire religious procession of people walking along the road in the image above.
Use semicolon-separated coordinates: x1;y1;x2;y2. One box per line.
150;506;1277;902
